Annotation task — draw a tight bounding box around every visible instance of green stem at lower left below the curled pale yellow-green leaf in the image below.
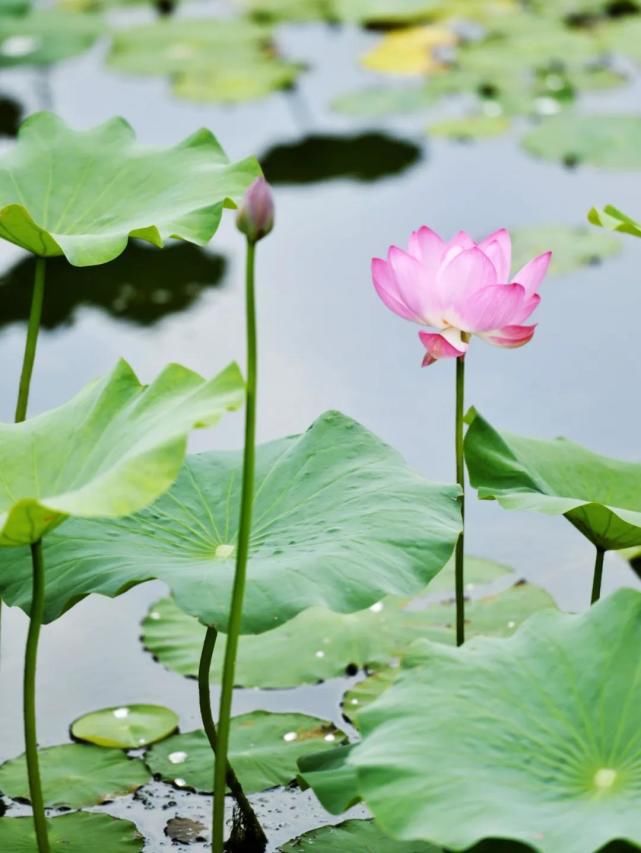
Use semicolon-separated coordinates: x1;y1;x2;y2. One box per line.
23;539;49;853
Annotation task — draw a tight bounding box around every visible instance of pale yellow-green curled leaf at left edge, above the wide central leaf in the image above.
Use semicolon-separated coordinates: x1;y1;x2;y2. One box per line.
0;361;244;544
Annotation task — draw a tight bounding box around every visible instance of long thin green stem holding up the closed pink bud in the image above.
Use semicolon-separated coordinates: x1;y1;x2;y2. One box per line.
212;239;256;853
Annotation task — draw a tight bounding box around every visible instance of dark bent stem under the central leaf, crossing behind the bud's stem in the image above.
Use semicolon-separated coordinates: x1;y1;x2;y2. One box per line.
198;628;267;853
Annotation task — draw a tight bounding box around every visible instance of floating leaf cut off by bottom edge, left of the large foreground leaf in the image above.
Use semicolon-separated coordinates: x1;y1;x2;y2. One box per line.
279;820;443;853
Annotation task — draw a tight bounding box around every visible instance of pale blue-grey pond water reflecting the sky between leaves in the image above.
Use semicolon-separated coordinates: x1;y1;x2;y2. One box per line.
0;6;641;851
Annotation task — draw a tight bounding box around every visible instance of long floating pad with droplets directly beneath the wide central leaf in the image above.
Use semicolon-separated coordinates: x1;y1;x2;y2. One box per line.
142;558;552;688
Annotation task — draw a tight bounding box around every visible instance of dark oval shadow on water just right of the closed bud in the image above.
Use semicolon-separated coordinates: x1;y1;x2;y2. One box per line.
260;132;423;184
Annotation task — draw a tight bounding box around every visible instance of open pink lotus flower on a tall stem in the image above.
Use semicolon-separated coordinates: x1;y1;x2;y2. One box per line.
372;226;552;367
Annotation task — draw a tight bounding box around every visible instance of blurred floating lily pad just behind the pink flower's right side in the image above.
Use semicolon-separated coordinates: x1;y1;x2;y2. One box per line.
512;225;623;275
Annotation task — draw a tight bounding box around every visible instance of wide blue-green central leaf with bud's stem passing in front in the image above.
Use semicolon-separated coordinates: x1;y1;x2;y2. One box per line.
0;412;460;633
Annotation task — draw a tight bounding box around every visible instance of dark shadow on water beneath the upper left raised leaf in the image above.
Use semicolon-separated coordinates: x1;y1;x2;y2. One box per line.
0;242;226;329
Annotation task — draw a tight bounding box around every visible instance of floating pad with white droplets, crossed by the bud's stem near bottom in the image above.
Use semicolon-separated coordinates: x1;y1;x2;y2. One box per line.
145;711;346;794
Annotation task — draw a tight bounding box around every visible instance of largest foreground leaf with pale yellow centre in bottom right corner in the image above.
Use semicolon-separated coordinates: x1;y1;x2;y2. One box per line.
348;590;641;853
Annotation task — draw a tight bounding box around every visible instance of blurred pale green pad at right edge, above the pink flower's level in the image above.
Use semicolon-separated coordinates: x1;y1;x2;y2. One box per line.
523;114;641;169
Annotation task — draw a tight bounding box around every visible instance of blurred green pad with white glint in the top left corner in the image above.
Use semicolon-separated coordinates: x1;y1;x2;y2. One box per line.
0;9;104;66
